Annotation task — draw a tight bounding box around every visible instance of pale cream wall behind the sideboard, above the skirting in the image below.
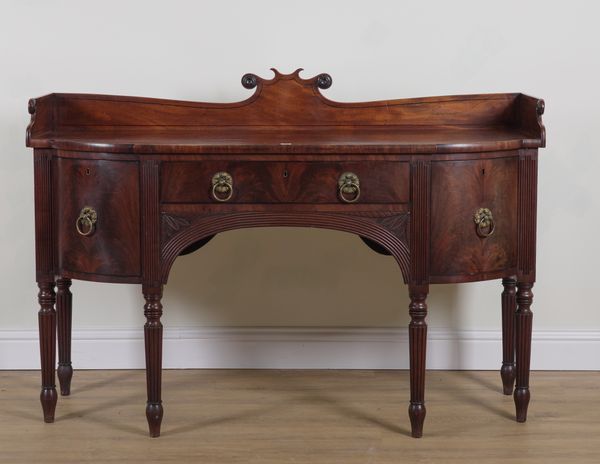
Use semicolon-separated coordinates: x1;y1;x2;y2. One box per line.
0;0;600;368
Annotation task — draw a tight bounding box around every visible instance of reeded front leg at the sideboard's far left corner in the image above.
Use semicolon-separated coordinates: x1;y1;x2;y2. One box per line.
38;282;58;422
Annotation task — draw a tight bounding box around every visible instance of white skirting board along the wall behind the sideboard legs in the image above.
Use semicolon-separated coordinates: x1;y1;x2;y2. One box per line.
0;327;600;370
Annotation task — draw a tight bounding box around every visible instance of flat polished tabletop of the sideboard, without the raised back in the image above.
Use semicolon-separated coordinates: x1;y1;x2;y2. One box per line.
27;125;539;154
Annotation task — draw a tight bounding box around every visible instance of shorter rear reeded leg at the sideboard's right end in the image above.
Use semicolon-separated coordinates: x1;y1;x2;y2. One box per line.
500;277;517;395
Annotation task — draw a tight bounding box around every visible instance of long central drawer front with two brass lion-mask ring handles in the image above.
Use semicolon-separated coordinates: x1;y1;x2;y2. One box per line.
161;161;409;204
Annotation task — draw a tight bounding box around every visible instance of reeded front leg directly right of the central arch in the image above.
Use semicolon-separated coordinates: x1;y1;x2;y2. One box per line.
408;286;428;438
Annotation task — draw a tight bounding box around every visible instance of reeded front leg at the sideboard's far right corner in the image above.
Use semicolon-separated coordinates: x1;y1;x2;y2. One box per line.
514;282;533;422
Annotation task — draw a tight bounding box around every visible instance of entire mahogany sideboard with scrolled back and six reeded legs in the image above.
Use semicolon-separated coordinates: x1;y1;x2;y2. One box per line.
27;69;545;437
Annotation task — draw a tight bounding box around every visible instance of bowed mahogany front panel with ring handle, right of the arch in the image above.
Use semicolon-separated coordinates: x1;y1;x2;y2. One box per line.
431;158;518;282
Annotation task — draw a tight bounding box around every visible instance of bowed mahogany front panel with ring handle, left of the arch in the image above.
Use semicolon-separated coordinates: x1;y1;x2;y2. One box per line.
55;158;141;277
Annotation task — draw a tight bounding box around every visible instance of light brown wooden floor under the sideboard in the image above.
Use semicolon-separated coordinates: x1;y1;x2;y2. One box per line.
0;370;600;464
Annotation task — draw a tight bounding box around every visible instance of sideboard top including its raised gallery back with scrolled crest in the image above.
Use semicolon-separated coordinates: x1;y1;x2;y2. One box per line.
27;69;545;153
